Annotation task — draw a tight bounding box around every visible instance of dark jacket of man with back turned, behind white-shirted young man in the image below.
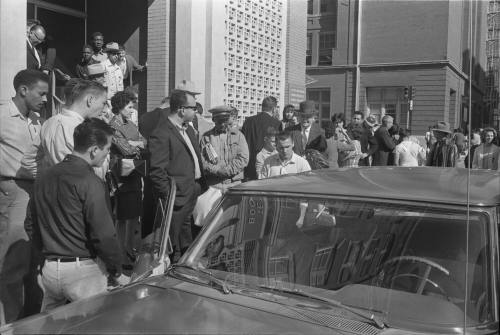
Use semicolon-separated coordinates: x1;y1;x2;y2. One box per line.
241;112;281;180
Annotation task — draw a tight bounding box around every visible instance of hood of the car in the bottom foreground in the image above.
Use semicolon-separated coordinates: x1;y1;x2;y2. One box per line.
0;276;345;335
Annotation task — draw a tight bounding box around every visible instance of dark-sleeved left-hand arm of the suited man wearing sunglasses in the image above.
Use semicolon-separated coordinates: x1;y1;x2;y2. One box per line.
148;128;170;197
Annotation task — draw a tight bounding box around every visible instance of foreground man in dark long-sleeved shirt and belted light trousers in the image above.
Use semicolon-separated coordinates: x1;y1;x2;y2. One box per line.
34;118;128;311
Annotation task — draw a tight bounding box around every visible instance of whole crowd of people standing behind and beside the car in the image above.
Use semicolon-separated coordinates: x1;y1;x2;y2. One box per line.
0;25;500;322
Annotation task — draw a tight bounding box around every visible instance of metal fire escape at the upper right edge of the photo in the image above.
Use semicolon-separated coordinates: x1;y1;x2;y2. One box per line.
485;0;500;129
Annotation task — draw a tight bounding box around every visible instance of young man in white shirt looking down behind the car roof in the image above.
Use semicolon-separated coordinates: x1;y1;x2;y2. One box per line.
259;131;311;179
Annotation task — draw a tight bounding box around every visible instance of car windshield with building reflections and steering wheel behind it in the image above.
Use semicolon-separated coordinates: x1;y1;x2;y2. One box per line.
182;194;494;331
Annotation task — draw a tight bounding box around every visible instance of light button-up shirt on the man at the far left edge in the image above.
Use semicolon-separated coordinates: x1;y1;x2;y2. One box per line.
0;100;43;179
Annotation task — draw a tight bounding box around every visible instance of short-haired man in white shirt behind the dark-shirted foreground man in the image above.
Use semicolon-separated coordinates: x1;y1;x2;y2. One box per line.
41;79;107;168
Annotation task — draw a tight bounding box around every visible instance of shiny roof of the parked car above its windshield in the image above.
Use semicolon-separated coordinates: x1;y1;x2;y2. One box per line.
229;166;500;206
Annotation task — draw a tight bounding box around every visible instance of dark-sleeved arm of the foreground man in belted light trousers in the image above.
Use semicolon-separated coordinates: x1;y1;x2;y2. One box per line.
80;177;122;277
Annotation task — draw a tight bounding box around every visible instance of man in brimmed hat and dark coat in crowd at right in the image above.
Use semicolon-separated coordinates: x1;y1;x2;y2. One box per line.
426;121;459;167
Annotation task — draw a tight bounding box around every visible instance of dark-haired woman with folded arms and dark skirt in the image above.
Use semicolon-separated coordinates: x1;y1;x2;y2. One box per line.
110;91;146;264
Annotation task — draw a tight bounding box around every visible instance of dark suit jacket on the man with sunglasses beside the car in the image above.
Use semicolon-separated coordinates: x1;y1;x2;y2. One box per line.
148;114;204;206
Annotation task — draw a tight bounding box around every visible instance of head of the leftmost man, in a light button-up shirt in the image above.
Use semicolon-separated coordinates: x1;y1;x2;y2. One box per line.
14;70;49;112
